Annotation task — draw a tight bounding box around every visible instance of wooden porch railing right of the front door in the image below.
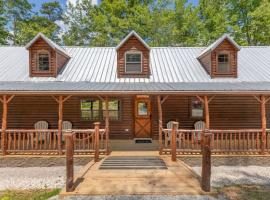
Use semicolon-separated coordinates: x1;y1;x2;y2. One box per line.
161;129;270;154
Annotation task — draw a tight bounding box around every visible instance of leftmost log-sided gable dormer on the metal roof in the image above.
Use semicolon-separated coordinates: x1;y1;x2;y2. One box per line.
25;33;70;77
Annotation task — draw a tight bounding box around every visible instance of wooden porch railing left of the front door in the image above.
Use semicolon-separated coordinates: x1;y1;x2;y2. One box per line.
1;125;108;154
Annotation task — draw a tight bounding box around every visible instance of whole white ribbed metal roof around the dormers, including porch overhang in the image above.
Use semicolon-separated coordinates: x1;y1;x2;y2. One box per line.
0;47;270;91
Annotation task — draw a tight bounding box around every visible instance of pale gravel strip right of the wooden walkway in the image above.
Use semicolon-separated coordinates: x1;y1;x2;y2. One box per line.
192;166;270;187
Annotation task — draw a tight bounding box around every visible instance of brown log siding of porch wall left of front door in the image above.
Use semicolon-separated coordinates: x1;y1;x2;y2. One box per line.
0;96;134;139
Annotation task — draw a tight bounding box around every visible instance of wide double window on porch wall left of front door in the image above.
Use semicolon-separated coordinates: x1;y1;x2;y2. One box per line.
81;100;120;121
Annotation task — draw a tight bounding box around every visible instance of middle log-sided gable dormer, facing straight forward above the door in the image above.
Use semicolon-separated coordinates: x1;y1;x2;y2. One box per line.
116;31;150;78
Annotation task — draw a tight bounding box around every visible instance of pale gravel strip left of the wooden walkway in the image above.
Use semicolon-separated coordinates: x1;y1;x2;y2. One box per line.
0;166;81;191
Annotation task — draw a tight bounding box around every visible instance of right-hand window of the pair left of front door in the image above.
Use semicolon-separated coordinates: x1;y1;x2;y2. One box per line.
102;100;120;120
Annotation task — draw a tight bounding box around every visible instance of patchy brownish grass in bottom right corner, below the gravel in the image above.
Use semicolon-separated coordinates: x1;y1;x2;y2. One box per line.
217;185;270;200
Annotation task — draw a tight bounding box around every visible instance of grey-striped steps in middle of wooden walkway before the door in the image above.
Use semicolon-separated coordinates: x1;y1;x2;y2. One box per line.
99;156;167;170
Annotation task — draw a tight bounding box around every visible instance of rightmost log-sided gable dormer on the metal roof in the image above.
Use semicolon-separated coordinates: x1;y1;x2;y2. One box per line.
197;34;240;78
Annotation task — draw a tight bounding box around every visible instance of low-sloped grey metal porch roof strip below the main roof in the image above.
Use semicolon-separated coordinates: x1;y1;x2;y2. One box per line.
0;82;270;94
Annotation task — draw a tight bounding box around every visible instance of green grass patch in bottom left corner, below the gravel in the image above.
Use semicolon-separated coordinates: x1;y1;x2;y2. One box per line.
0;189;60;200
